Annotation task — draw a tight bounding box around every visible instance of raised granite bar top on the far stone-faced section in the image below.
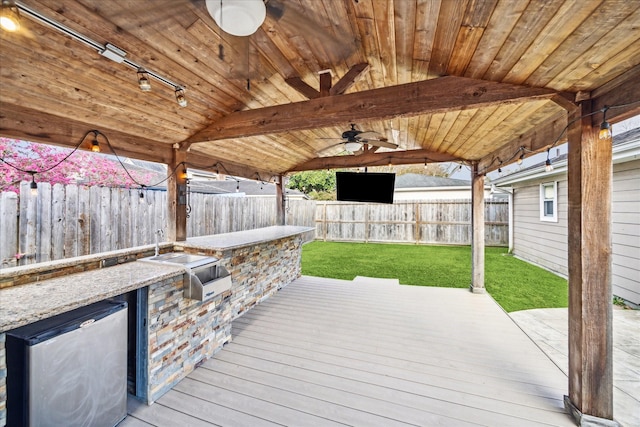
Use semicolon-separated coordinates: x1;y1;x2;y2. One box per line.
176;225;315;250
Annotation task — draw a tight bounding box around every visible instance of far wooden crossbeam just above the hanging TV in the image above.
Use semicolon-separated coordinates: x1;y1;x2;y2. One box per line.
288;150;460;172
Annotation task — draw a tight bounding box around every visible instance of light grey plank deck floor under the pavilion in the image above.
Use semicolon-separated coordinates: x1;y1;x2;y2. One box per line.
121;276;575;427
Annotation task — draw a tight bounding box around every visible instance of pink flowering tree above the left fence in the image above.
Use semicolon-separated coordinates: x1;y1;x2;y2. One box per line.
0;138;164;193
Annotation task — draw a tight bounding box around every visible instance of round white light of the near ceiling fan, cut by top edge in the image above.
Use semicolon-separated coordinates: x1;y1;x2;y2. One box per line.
206;0;267;37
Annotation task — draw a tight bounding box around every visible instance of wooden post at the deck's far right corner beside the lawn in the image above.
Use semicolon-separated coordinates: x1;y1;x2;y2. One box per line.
471;163;485;293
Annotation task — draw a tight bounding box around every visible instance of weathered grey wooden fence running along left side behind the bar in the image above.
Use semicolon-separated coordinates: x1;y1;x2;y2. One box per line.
0;182;315;268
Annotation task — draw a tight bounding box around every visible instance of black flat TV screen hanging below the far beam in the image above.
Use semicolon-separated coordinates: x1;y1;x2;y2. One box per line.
336;172;396;203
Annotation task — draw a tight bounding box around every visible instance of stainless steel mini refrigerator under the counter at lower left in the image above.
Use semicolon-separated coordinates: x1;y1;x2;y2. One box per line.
6;301;127;427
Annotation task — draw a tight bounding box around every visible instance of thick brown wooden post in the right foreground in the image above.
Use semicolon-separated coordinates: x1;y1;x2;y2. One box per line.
565;101;617;425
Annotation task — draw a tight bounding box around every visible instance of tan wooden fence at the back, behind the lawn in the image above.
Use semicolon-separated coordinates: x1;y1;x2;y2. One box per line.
316;200;509;246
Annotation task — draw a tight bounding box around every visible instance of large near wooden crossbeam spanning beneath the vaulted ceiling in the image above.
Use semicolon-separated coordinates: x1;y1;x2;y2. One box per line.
185;76;557;145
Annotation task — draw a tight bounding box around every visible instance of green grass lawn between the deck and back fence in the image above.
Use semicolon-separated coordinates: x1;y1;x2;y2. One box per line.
302;241;568;312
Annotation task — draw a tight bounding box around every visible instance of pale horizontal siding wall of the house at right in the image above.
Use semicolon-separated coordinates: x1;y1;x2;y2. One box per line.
513;160;640;304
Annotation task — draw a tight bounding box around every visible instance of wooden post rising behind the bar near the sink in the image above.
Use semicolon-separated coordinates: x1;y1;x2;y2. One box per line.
167;149;187;242
